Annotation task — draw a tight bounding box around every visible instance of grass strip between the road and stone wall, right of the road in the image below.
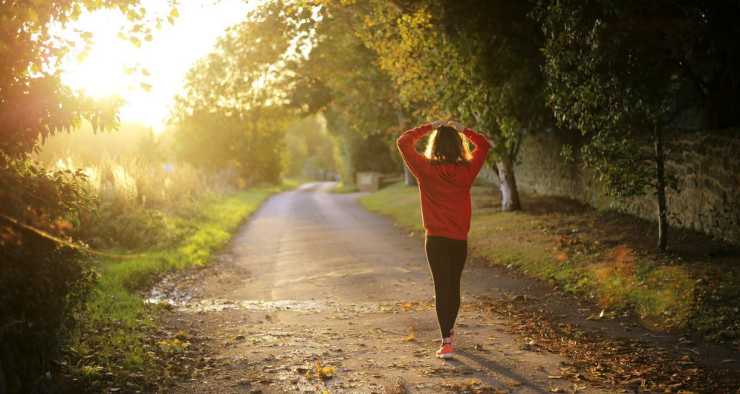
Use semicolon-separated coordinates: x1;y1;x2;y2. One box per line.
361;183;740;338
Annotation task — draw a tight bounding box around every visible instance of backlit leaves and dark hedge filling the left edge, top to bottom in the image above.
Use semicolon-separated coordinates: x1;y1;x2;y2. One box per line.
0;0;178;392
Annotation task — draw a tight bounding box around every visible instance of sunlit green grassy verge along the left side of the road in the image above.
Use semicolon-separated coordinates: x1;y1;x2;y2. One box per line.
68;182;295;390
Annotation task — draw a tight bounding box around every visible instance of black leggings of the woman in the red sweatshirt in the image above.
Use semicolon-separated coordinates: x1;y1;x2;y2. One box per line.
425;236;468;338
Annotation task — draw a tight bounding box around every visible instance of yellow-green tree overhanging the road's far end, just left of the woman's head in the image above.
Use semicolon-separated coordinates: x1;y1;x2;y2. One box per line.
291;3;408;184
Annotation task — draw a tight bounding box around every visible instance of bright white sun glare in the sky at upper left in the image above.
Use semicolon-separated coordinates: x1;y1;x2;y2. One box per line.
58;0;254;132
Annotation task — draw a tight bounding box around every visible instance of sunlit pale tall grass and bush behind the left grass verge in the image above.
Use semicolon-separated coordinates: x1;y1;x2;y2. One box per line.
50;157;234;251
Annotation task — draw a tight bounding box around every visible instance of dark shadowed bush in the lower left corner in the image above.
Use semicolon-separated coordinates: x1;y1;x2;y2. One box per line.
0;240;95;392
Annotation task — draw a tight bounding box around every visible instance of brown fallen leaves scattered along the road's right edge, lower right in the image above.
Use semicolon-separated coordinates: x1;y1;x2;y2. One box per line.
478;298;740;393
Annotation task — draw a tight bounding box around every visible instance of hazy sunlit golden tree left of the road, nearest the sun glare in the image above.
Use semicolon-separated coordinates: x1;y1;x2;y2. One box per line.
174;1;304;183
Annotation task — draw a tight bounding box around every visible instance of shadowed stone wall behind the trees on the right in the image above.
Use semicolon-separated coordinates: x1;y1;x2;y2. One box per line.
484;130;740;244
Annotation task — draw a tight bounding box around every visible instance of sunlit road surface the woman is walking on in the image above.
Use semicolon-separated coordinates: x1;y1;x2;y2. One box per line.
155;183;736;393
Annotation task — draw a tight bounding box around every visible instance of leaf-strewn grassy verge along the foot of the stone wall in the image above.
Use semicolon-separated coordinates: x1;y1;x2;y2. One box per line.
361;184;740;346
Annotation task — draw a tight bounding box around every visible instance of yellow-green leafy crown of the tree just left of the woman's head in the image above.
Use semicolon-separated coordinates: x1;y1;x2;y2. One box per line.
291;3;403;136
